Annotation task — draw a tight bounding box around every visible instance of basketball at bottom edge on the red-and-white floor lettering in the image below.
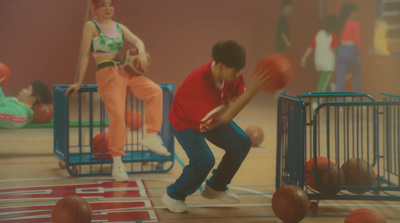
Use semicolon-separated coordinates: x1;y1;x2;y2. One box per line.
51;196;92;223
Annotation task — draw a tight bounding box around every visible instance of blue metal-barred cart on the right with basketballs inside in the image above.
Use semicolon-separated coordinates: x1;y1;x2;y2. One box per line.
276;92;400;211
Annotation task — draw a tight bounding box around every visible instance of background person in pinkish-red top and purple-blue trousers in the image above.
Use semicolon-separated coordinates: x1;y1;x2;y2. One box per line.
336;3;366;92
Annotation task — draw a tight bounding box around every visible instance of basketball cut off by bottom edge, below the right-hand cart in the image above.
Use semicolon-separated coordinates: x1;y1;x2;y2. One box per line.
344;208;387;223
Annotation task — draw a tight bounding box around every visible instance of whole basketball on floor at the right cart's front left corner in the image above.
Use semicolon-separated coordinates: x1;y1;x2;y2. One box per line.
272;185;310;223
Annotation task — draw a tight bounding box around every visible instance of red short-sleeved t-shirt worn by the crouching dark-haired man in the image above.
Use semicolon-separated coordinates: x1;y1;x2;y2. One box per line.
168;61;245;132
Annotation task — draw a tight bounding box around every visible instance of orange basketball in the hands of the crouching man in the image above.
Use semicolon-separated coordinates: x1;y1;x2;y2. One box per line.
254;54;293;93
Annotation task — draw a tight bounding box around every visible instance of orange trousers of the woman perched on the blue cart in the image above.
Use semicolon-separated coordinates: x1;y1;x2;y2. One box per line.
96;65;163;157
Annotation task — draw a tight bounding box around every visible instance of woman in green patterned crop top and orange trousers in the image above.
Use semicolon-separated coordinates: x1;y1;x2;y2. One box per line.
66;0;169;181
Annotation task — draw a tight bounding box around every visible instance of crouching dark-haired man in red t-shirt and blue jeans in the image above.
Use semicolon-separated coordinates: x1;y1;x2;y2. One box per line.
162;41;267;213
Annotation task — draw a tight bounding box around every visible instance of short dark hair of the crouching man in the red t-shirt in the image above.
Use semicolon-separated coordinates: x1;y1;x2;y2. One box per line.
212;40;246;69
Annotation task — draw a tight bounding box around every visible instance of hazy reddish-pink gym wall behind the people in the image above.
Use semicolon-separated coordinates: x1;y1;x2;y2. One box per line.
0;0;400;95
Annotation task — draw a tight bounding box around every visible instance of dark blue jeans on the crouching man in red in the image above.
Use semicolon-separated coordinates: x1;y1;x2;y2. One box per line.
167;122;251;201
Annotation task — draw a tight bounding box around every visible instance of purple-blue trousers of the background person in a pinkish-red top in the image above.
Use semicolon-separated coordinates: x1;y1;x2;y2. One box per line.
336;45;361;92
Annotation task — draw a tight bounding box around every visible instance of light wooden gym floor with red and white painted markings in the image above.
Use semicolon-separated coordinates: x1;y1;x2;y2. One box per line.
0;94;400;223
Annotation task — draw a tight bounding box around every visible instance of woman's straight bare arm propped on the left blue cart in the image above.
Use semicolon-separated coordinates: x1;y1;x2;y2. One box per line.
65;21;95;96
